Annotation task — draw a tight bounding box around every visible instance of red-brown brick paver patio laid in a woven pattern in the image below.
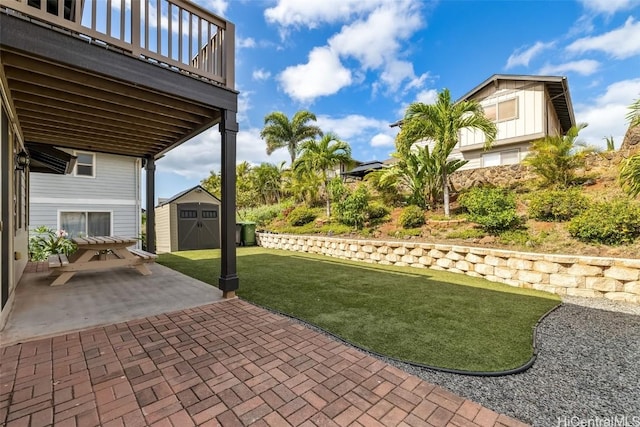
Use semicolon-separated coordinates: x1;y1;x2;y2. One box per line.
0;299;524;427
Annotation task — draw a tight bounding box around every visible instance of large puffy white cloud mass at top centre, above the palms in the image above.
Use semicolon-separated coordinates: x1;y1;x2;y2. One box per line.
276;0;428;101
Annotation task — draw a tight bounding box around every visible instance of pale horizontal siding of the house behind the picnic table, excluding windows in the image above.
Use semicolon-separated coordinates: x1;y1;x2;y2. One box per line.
29;150;141;241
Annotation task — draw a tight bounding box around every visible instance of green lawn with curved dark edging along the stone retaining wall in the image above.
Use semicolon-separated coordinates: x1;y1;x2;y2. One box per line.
159;247;560;371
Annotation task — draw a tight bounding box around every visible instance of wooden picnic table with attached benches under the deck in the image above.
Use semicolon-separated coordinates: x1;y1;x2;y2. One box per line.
49;236;157;286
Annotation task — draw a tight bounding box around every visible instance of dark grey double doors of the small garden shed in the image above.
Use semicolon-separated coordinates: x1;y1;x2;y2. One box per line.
178;203;220;251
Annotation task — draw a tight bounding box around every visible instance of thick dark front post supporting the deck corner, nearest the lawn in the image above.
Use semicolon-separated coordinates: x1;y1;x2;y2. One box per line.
218;110;238;298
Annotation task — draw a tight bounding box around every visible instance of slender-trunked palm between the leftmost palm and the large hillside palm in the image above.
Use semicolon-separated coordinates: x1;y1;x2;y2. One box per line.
293;133;353;217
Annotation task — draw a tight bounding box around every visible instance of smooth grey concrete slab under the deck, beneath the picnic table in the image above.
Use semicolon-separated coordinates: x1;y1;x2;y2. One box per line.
0;263;222;345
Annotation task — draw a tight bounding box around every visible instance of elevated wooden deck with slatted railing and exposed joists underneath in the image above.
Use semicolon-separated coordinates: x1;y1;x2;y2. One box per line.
0;0;237;158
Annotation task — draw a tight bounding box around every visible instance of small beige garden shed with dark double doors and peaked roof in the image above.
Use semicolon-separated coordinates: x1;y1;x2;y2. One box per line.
155;185;221;253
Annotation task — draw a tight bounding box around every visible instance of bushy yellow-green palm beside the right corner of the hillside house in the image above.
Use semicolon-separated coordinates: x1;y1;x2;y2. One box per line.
523;123;593;188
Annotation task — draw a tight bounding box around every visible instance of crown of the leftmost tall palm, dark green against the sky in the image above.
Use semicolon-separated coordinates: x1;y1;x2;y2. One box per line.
260;110;322;164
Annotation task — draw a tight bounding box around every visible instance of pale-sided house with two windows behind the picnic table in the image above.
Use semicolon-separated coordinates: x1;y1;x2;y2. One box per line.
29;150;142;241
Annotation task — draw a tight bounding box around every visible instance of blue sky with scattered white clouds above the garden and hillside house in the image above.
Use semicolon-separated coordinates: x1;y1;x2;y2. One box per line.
156;0;640;202
